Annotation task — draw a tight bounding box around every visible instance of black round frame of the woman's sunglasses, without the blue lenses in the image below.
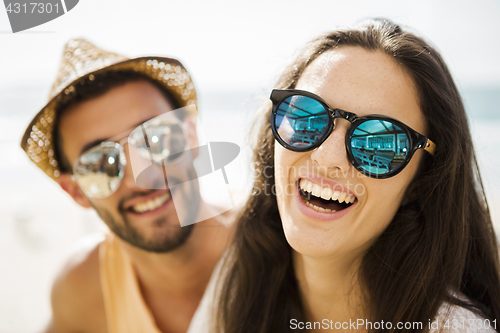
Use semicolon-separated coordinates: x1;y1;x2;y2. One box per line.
270;89;436;179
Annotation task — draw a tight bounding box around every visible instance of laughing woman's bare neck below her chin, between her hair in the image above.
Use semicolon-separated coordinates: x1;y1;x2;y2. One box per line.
293;251;366;330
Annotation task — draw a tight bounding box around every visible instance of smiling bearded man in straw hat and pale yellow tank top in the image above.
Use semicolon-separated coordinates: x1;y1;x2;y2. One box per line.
21;40;235;333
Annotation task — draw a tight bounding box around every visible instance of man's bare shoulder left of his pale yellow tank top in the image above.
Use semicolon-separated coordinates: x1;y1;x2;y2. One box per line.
48;236;106;333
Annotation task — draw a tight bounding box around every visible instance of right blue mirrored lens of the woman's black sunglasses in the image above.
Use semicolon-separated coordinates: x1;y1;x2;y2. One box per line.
351;119;410;177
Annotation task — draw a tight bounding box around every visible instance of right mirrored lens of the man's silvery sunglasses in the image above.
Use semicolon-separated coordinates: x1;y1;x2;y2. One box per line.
128;117;187;163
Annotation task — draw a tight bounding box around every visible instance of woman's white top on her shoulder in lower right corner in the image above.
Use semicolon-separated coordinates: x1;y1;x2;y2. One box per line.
430;303;498;333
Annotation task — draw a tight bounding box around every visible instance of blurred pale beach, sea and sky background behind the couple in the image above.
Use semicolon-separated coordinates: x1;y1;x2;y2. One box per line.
0;0;500;333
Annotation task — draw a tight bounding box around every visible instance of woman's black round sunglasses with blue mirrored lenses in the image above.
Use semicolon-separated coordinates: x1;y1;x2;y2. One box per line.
271;89;436;179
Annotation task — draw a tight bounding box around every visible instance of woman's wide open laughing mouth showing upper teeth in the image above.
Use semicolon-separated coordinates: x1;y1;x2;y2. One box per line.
299;179;357;213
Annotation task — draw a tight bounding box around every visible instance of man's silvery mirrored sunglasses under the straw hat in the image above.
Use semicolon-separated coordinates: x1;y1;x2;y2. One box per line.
73;116;188;198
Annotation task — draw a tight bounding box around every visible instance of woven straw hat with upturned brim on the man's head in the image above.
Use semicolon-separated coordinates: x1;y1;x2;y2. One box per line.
21;39;197;180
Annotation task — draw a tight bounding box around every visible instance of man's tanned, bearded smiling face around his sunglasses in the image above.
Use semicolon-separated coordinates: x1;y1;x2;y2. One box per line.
59;80;194;252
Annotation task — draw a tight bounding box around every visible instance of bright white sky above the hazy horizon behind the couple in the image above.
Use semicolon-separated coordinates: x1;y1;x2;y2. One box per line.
0;0;500;97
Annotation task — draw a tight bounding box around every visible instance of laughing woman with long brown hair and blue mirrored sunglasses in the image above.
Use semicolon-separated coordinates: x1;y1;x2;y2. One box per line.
188;20;500;333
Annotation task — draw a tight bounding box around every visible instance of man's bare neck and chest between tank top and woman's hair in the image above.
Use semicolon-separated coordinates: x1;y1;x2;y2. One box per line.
116;200;233;333
